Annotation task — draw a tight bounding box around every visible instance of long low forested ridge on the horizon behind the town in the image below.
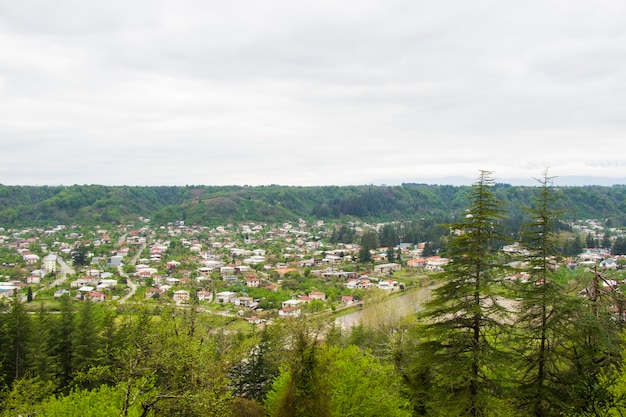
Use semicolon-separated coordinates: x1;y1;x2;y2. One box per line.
0;184;626;227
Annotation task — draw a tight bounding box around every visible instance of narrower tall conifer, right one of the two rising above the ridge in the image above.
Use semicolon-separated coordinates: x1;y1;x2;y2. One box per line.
514;172;573;417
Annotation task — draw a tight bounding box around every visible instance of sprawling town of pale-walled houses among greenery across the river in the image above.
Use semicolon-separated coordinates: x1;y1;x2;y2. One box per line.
0;218;626;324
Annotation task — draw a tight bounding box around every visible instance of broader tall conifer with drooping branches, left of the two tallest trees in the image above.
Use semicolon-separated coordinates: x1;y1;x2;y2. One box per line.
417;171;508;417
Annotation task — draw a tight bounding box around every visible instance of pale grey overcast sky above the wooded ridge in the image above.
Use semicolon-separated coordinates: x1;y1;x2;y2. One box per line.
0;0;626;185
